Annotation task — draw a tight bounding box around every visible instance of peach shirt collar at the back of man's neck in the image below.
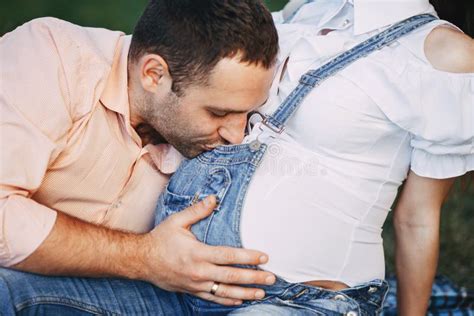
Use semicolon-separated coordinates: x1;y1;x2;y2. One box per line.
100;35;131;121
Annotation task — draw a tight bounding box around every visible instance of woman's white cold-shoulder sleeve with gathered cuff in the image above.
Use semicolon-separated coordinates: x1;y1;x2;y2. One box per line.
392;21;474;179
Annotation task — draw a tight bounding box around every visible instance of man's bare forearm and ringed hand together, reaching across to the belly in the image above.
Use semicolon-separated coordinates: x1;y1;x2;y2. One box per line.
11;197;275;305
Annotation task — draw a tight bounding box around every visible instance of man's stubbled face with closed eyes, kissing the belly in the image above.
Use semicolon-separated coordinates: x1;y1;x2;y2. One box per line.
142;58;274;158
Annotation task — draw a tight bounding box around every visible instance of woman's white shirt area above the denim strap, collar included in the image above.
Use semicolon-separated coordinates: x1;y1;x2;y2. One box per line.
277;0;436;96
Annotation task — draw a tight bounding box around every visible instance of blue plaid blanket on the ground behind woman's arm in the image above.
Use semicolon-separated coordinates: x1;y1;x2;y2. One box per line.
382;276;474;316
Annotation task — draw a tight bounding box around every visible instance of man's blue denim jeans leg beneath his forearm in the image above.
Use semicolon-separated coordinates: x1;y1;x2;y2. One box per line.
0;268;192;316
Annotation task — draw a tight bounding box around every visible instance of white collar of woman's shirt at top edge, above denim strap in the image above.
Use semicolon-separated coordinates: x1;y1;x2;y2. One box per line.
353;0;436;35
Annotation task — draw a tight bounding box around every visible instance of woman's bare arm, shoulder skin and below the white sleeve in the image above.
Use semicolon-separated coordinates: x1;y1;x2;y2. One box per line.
394;26;474;316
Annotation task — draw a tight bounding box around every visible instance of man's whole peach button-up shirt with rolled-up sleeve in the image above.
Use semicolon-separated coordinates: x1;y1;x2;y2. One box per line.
0;18;181;266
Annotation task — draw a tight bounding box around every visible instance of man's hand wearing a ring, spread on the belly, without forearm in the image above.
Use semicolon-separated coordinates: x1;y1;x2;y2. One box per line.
142;196;275;305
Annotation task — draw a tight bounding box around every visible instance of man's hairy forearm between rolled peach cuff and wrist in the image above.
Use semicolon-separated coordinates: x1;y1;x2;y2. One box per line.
12;213;145;278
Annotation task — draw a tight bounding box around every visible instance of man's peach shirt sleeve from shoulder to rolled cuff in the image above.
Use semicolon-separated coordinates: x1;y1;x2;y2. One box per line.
0;19;72;267
